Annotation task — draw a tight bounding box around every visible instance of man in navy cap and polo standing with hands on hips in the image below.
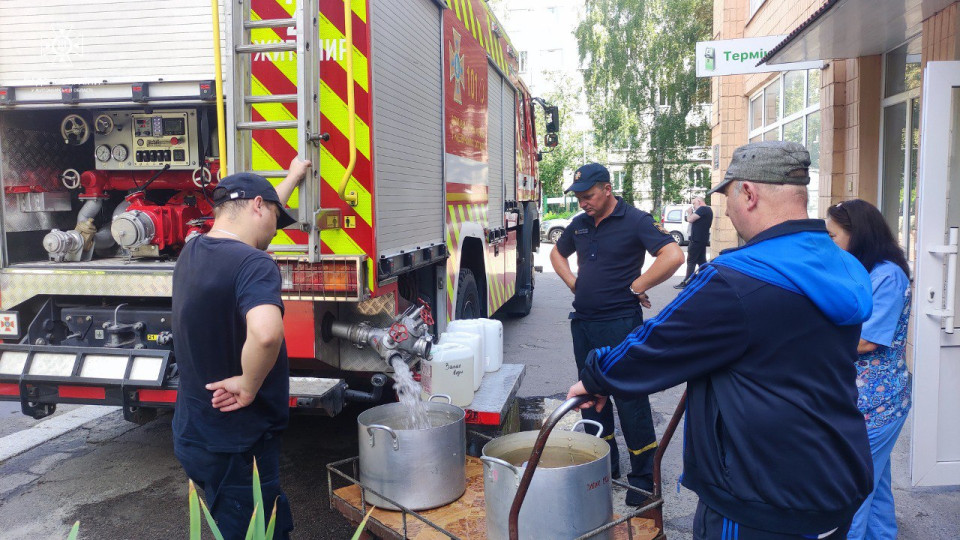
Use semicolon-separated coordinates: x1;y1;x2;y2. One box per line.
550;163;683;506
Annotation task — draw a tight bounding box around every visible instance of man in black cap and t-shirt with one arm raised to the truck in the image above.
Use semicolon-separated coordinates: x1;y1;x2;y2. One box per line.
172;159;310;539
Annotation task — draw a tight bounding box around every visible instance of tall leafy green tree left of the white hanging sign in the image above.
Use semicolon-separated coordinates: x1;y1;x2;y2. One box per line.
576;0;713;210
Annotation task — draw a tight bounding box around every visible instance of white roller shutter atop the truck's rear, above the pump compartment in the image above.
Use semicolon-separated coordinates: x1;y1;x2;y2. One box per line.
0;0;230;86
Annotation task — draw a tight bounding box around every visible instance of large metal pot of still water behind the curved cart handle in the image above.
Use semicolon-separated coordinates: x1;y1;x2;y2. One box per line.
480;398;613;540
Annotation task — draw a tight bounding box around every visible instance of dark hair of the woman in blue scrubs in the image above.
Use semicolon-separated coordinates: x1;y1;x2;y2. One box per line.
827;199;910;278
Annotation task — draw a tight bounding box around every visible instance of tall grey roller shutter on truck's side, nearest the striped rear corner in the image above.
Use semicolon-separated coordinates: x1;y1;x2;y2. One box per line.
370;0;443;259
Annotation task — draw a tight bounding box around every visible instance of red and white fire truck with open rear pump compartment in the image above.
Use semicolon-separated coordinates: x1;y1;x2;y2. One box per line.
0;0;559;422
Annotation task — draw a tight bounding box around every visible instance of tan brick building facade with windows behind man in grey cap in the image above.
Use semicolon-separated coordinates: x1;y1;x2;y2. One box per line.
711;0;960;261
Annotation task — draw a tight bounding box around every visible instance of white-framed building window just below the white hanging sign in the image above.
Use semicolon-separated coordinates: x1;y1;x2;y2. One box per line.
748;68;820;217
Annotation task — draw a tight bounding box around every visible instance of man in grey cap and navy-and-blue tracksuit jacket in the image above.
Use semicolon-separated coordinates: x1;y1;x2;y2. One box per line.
569;141;873;540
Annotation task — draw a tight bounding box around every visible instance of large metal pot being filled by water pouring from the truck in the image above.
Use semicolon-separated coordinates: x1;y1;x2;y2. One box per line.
357;395;467;510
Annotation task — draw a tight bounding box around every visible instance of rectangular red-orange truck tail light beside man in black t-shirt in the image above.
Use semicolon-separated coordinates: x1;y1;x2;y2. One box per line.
280;259;362;299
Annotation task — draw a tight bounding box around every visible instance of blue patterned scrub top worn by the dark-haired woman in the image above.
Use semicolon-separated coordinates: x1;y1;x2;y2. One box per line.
857;261;910;429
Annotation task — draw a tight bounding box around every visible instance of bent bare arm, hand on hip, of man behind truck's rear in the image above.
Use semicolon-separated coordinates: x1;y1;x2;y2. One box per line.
207;304;283;412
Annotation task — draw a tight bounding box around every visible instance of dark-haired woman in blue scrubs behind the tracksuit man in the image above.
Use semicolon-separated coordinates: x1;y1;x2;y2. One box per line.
827;199;910;539
